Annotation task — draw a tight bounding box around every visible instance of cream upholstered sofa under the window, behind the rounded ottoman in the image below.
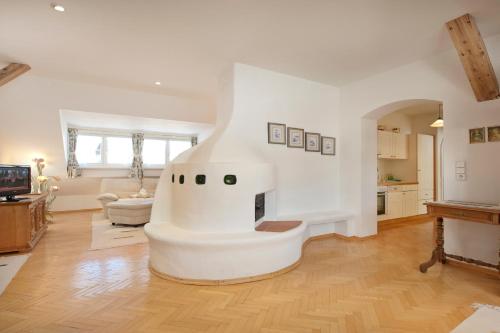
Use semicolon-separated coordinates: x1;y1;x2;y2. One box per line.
97;178;158;218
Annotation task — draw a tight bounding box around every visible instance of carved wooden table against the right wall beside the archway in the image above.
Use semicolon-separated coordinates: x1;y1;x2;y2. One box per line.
420;201;500;273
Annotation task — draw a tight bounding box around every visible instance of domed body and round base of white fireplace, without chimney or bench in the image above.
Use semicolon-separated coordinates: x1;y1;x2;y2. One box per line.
145;126;305;283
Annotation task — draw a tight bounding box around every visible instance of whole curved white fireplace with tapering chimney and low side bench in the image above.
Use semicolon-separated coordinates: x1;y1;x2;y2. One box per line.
145;68;348;284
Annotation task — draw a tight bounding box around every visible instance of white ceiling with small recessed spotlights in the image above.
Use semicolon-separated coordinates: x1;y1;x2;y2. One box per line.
0;0;500;97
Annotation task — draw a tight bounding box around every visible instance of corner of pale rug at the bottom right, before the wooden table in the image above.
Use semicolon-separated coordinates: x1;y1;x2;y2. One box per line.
451;303;500;333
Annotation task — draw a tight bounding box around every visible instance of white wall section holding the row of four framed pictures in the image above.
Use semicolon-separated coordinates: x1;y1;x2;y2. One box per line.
228;64;340;215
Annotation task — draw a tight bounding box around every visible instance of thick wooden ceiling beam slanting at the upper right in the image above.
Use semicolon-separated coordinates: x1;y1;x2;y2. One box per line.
446;14;500;102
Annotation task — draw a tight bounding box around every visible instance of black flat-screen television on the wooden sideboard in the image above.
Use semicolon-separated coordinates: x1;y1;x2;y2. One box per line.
0;164;31;201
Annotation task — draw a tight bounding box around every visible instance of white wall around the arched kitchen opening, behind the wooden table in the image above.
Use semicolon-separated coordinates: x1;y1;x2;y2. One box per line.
339;36;500;263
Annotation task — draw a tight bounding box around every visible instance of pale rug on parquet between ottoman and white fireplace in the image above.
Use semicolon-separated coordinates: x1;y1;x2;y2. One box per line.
90;213;148;250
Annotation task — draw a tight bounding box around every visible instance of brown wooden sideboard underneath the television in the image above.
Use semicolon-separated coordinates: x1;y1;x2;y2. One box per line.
0;194;47;252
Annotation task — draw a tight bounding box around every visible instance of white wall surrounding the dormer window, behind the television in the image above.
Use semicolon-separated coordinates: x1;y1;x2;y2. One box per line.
0;73;215;210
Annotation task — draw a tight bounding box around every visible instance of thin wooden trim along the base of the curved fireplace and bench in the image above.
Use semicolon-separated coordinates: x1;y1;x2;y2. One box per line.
149;233;377;286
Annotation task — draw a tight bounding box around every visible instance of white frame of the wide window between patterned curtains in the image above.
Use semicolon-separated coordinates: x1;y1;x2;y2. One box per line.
71;126;193;170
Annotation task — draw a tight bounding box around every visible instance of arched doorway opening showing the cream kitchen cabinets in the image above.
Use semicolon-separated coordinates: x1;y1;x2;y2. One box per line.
362;99;443;232
